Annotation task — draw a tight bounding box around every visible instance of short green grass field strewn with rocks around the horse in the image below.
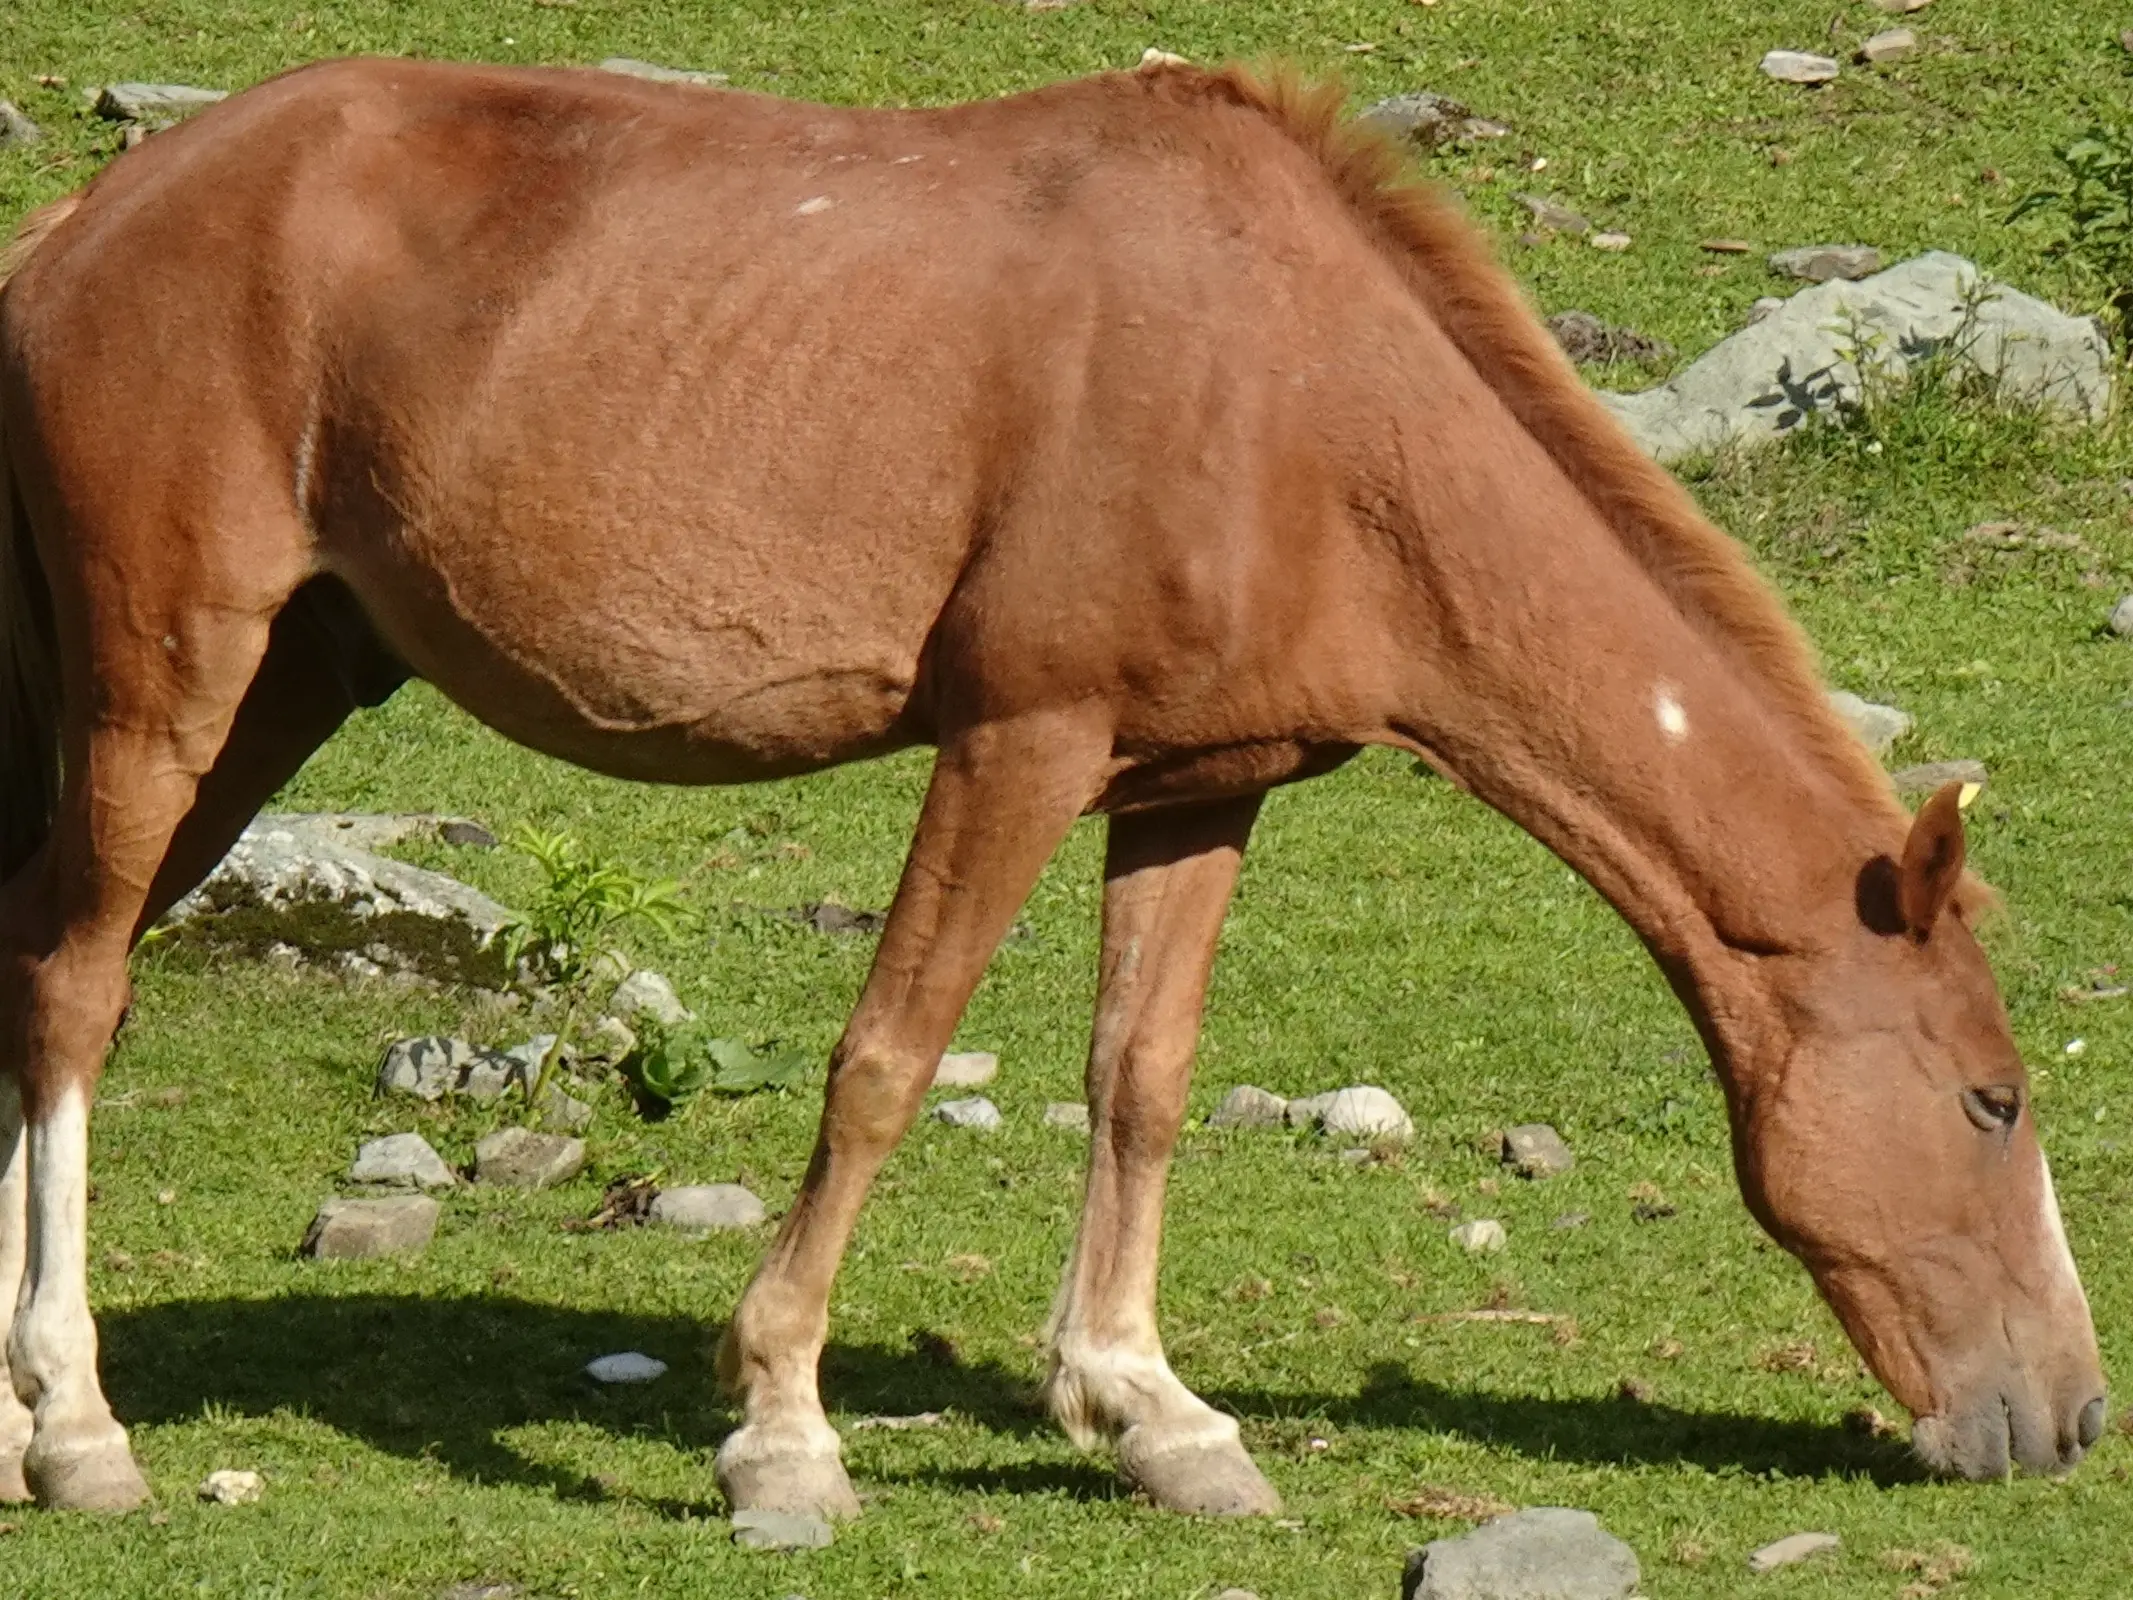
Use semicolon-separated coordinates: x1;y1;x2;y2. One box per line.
0;0;2133;1600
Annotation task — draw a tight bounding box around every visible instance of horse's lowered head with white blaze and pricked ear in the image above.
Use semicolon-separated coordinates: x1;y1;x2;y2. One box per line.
1734;785;2103;1478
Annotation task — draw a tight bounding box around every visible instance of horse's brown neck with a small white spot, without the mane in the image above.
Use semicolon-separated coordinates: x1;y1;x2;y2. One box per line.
1395;429;1903;1066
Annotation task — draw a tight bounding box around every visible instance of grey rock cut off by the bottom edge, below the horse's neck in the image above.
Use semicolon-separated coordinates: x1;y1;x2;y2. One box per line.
1399;1506;1640;1600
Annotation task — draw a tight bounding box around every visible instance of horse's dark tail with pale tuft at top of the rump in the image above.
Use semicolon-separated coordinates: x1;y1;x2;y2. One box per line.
0;194;81;883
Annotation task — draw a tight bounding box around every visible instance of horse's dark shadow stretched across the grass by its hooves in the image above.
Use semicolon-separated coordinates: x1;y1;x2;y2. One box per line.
100;1293;1918;1517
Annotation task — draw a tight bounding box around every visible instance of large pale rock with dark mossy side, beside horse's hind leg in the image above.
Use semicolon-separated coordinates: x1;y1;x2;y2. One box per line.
164;815;510;988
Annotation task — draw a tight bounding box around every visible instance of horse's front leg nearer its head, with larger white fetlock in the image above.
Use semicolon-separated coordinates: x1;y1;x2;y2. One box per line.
1045;796;1282;1515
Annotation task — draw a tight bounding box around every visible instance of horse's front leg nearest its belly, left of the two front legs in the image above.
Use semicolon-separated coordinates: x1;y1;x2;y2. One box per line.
717;710;1111;1517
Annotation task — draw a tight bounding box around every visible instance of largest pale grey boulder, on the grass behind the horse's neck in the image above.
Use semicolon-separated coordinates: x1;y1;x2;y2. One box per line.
1600;252;2114;461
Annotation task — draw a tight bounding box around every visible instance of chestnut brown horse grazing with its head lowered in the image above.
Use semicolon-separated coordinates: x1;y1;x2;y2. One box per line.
0;62;2103;1513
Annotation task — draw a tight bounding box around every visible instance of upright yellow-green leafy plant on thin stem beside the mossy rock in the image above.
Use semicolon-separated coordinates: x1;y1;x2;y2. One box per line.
499;823;689;1116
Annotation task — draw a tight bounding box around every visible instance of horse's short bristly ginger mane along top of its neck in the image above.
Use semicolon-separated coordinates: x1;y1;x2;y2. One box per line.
1143;66;1909;836
